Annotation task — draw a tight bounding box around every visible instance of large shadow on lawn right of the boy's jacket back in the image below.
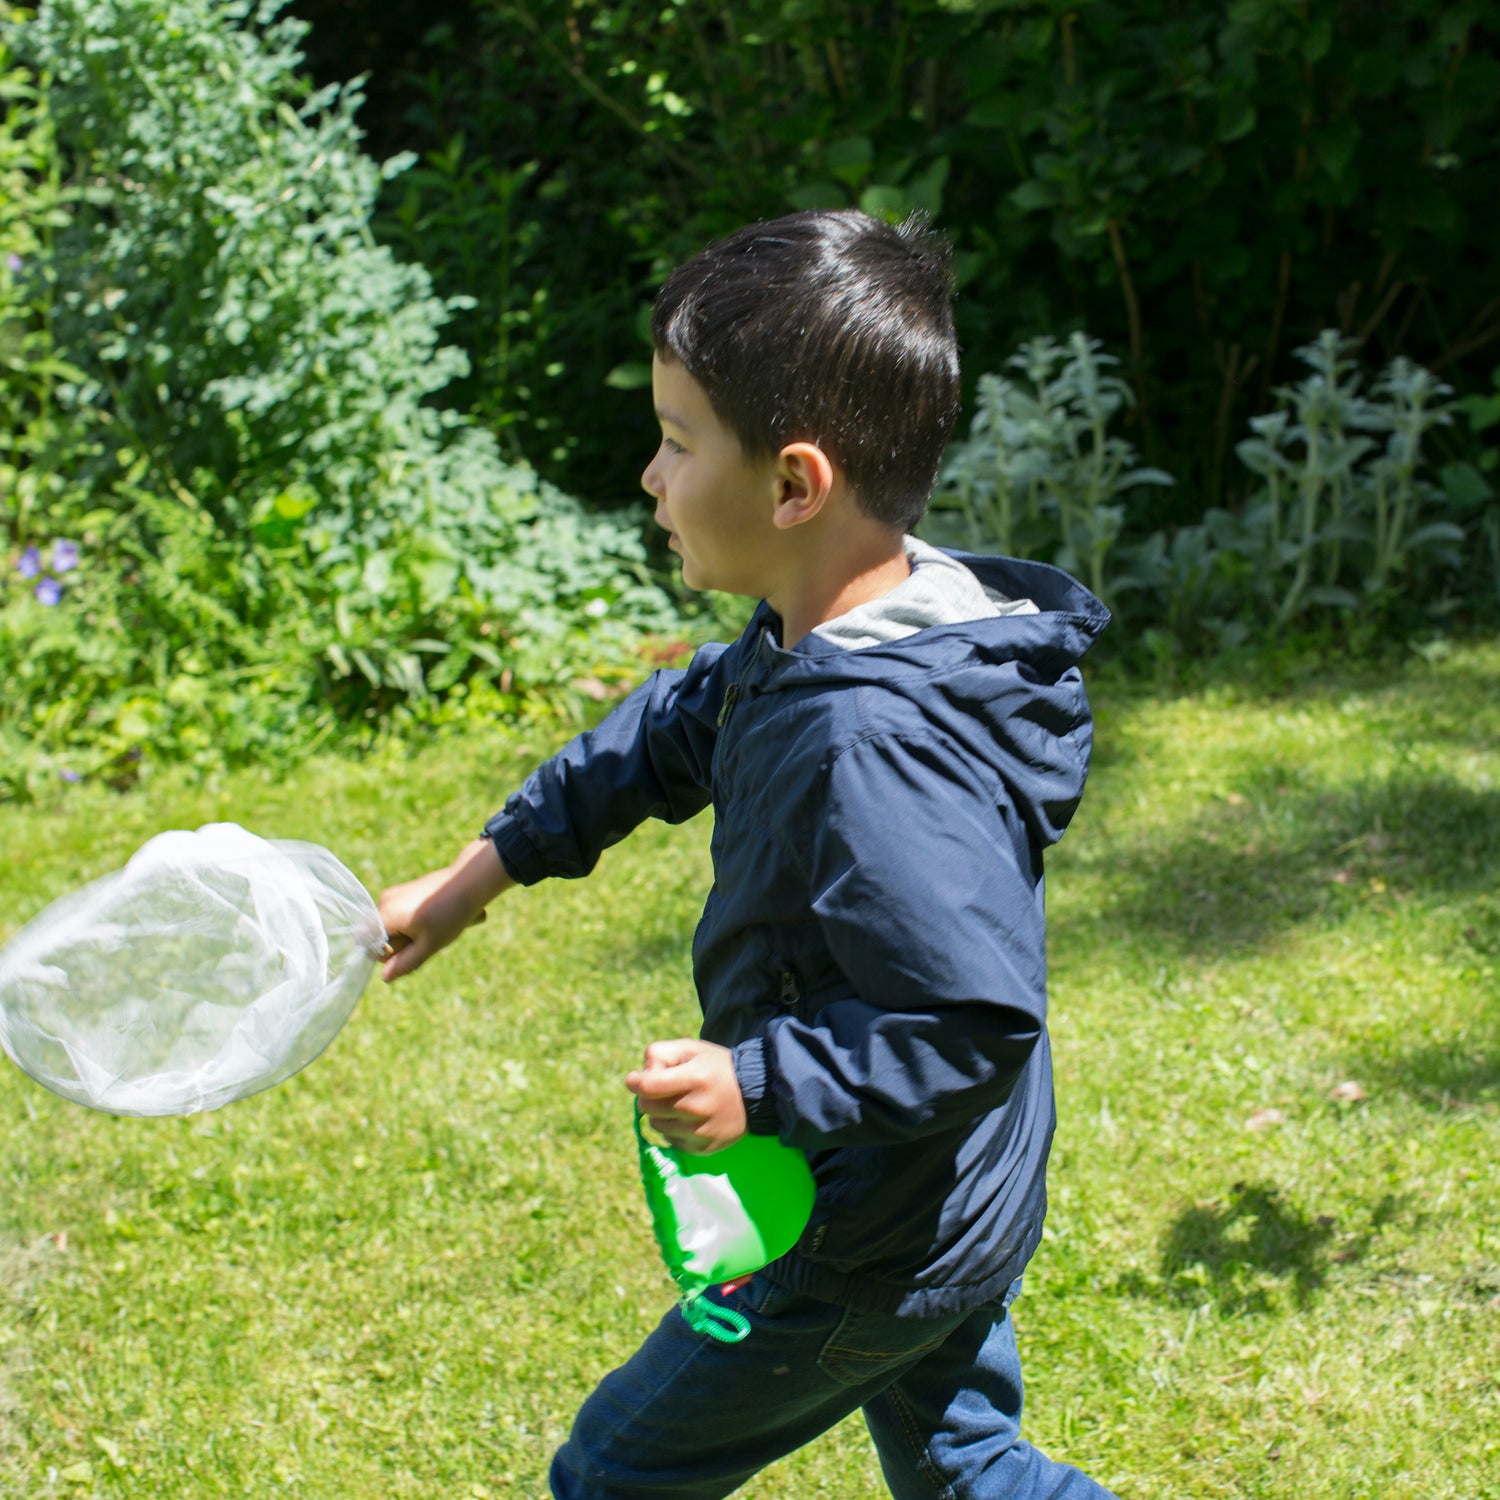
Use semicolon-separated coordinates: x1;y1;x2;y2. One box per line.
1070;767;1500;957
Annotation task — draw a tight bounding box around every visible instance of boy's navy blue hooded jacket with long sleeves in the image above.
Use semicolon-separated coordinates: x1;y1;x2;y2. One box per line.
486;555;1109;1316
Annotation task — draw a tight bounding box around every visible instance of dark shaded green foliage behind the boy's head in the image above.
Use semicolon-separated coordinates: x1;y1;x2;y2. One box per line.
310;0;1500;522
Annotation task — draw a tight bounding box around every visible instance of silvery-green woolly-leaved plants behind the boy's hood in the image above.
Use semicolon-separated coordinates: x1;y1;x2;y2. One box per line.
929;330;1476;654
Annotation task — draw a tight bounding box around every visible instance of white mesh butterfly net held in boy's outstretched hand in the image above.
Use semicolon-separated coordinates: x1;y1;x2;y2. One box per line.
0;824;386;1115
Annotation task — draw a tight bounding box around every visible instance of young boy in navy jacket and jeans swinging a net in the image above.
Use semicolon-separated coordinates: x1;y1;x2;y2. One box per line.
381;212;1109;1500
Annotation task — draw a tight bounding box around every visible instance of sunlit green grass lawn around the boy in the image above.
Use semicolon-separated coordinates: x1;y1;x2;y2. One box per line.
0;645;1500;1500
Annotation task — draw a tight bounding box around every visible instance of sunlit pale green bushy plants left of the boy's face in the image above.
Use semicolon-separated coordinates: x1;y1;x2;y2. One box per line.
0;0;675;795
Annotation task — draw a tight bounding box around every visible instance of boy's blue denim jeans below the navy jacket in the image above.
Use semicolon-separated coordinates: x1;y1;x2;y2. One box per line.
552;1275;1110;1500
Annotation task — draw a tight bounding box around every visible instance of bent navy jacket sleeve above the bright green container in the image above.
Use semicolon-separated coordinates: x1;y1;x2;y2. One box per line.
735;737;1047;1151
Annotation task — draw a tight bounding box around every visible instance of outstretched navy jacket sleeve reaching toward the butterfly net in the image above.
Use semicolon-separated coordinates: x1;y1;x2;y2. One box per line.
485;645;734;885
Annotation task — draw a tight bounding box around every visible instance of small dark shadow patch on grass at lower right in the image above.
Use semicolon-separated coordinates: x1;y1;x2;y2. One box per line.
1121;1182;1401;1316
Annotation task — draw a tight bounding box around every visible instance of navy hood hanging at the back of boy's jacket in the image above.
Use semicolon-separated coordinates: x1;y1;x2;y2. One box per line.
741;552;1110;845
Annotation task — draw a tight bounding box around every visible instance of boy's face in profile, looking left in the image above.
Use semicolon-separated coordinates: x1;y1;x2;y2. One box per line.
641;356;782;597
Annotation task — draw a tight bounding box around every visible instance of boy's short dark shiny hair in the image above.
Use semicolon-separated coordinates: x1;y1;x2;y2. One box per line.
651;209;959;531
